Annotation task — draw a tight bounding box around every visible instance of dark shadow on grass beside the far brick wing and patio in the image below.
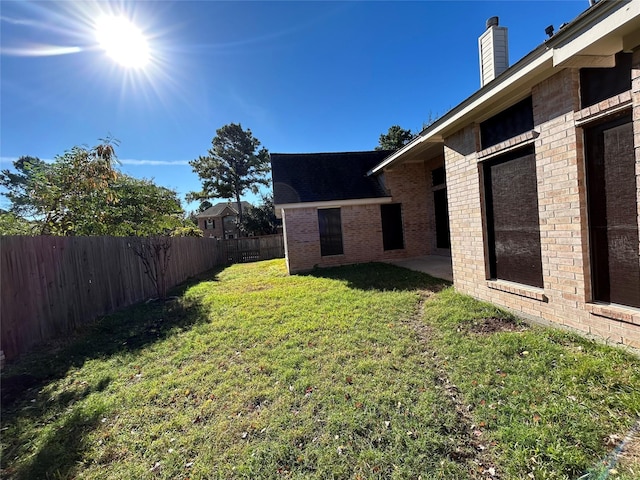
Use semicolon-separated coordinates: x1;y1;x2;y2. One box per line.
306;262;451;292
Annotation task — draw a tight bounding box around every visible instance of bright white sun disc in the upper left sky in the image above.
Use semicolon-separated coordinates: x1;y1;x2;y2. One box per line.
95;15;150;68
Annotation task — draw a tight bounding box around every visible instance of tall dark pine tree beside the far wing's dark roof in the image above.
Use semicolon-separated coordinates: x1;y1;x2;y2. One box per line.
187;123;270;230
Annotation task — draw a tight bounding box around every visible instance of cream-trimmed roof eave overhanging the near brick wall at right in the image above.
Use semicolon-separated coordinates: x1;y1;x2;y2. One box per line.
369;0;640;174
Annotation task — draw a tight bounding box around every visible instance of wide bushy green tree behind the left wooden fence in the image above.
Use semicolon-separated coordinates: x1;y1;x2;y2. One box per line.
0;140;183;236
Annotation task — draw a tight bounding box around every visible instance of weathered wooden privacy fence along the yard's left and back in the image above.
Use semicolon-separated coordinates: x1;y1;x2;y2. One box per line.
0;235;284;359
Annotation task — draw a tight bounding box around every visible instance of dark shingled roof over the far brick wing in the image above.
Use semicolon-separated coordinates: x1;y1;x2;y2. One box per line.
271;150;391;205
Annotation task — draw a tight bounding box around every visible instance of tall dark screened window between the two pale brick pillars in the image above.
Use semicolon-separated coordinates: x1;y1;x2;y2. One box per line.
484;147;543;287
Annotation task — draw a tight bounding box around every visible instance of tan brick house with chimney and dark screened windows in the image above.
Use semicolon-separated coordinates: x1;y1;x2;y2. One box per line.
273;0;640;347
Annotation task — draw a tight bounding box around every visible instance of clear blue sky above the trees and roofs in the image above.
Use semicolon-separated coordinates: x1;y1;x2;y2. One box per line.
0;0;589;209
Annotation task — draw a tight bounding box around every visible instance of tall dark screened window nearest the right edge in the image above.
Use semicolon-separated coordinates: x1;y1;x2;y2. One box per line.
585;115;640;307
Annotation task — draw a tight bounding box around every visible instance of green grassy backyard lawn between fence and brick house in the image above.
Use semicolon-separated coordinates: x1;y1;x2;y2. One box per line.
0;260;640;480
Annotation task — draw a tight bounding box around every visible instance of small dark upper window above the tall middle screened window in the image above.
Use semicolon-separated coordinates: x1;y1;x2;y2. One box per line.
480;97;533;149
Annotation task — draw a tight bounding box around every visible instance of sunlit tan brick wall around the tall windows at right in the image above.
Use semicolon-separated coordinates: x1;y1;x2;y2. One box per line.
445;65;640;347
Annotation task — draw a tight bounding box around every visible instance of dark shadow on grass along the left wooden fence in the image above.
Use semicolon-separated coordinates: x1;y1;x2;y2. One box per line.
0;267;224;479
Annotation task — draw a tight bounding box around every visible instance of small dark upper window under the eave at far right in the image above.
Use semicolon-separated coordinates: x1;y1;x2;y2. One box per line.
580;52;631;108
